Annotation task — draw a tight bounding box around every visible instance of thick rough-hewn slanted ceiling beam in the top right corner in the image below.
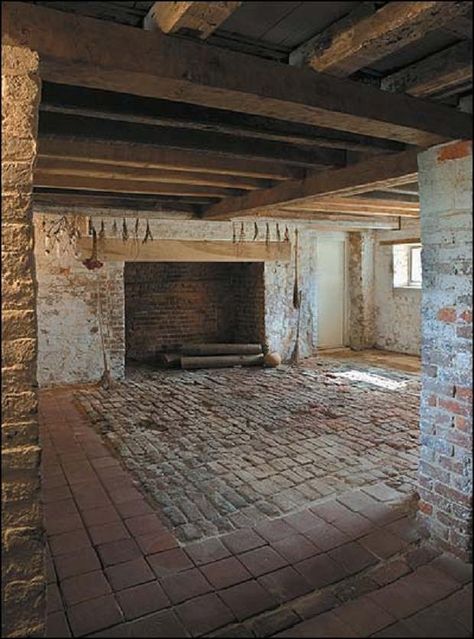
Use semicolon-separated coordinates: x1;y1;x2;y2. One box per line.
290;1;472;77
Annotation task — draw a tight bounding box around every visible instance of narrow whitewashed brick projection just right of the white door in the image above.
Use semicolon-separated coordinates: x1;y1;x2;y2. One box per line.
349;231;375;351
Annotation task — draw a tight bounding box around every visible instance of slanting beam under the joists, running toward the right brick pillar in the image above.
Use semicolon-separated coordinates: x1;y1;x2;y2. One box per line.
204;150;418;220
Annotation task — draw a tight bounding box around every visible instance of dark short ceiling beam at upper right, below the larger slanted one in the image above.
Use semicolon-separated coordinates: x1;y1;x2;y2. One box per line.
380;40;472;98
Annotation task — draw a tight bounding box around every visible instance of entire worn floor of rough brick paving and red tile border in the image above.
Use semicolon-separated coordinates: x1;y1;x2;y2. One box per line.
40;361;472;637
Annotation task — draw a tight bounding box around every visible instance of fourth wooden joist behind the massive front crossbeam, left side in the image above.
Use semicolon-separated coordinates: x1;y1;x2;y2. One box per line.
35;156;272;191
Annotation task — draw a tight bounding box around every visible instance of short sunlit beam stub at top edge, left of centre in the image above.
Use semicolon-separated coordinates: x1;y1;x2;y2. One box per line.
143;2;242;40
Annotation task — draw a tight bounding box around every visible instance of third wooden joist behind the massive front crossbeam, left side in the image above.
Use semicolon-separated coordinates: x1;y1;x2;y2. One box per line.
38;136;305;180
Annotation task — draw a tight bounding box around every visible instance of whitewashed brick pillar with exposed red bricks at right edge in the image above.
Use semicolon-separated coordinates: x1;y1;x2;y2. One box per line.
418;142;472;559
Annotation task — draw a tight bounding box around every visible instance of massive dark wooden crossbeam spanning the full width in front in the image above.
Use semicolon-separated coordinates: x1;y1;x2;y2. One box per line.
2;2;472;146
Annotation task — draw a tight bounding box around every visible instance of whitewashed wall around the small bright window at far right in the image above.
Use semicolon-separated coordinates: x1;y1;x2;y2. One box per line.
374;221;421;355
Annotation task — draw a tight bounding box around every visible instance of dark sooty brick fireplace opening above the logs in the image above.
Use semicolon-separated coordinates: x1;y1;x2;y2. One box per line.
125;262;264;362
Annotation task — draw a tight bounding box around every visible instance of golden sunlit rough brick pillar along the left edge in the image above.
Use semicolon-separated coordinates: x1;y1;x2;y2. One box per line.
2;46;44;637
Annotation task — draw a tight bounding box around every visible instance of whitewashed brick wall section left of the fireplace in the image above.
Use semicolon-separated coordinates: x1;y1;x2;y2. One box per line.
35;215;125;387
